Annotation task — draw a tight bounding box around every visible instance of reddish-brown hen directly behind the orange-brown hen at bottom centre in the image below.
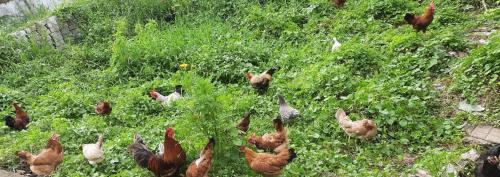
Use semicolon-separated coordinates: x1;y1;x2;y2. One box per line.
248;118;288;150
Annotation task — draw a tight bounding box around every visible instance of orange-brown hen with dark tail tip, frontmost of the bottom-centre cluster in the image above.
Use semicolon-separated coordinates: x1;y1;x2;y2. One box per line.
240;143;297;177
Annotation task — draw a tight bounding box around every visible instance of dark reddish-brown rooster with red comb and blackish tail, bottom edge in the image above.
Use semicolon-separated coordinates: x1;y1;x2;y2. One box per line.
128;128;186;176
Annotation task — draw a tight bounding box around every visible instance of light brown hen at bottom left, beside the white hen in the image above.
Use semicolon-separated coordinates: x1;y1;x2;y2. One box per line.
17;134;64;176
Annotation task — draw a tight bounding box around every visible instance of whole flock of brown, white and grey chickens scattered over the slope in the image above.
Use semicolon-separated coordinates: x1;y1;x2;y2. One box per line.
4;0;500;177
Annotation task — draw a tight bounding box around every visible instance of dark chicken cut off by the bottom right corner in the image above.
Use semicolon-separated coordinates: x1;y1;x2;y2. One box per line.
476;145;500;177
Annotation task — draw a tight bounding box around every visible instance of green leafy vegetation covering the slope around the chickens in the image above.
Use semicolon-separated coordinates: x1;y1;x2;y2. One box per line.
0;0;500;176
